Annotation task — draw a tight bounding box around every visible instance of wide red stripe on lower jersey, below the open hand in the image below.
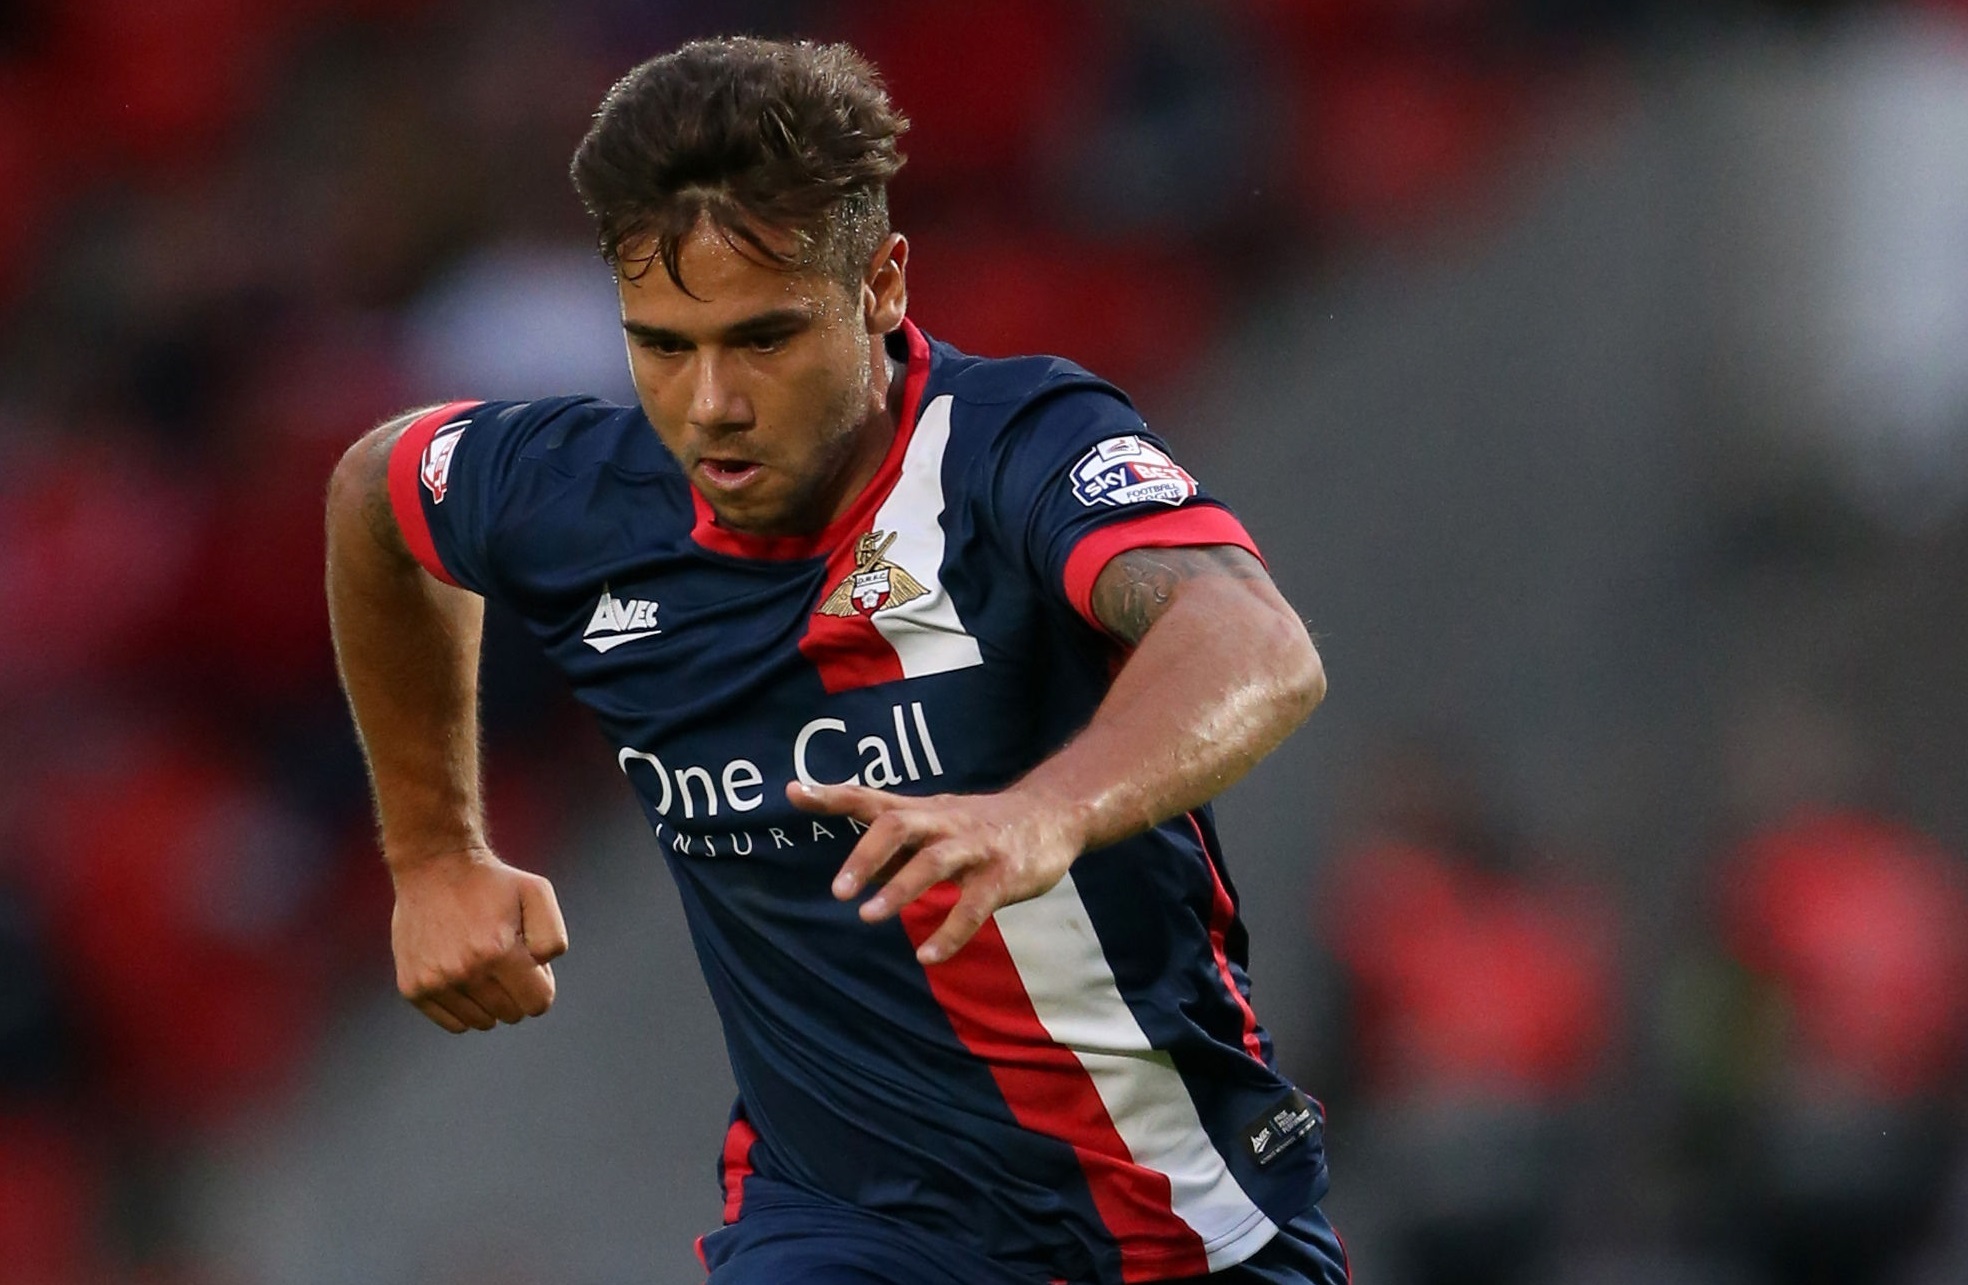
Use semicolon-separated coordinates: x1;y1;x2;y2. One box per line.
901;884;1208;1281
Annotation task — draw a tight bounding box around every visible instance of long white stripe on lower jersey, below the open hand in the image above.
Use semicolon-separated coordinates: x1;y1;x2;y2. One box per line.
996;874;1277;1271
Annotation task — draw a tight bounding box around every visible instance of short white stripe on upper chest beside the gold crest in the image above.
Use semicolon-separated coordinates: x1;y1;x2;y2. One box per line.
870;396;984;679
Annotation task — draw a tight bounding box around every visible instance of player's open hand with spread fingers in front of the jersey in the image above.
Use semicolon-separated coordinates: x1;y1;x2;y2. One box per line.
785;781;1084;964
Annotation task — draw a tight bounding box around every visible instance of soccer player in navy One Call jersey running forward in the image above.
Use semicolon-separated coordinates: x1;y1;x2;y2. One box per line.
329;39;1346;1285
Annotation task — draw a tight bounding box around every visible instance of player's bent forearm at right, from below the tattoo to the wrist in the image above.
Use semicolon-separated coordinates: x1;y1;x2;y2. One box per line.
1017;559;1324;848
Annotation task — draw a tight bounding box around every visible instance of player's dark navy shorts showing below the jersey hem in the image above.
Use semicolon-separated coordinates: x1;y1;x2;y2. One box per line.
697;1204;1350;1285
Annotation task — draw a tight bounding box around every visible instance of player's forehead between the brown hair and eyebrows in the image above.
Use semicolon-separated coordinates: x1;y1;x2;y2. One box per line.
616;220;846;335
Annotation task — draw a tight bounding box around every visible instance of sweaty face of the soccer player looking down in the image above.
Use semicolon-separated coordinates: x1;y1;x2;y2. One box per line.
618;222;901;535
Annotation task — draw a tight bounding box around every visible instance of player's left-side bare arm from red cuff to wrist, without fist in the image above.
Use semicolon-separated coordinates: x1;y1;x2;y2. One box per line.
327;429;486;870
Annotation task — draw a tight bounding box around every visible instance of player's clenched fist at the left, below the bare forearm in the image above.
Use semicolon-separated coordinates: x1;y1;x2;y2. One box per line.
390;848;567;1035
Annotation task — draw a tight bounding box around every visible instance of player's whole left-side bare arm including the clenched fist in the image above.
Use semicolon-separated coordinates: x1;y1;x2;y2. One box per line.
327;413;567;1033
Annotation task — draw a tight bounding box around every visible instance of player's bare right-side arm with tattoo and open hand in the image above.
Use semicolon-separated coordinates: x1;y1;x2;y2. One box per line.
787;545;1326;964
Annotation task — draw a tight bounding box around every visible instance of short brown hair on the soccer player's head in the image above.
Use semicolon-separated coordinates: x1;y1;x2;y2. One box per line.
571;35;909;293
